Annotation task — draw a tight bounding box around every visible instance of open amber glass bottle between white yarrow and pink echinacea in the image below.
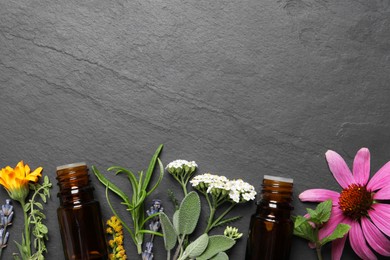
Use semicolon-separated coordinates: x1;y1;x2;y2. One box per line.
245;175;294;260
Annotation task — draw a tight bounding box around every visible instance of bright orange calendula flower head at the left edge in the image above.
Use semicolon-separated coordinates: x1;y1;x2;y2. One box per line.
0;161;43;202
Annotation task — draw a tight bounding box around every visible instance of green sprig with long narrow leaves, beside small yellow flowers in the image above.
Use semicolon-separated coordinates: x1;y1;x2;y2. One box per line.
92;144;164;254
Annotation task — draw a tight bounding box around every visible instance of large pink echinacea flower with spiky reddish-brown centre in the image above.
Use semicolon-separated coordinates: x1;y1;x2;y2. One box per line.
299;148;390;259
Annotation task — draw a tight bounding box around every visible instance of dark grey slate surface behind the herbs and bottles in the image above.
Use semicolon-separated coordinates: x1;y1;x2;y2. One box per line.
0;0;390;259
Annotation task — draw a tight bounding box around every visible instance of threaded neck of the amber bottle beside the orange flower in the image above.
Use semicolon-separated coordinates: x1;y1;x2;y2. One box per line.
57;163;94;206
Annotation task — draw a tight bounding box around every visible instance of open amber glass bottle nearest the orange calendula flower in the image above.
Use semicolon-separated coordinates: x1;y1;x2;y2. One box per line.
57;163;108;260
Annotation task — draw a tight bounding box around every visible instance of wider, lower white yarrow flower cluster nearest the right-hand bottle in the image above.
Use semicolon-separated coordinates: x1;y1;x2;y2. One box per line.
190;173;256;203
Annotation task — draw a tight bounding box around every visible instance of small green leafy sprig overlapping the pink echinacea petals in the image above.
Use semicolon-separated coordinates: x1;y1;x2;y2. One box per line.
293;200;351;260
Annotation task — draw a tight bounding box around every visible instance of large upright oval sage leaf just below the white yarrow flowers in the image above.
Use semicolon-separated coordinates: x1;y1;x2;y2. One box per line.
177;191;200;235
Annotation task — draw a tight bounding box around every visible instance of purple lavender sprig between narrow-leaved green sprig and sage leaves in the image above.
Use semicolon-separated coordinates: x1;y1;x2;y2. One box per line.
142;199;164;260
